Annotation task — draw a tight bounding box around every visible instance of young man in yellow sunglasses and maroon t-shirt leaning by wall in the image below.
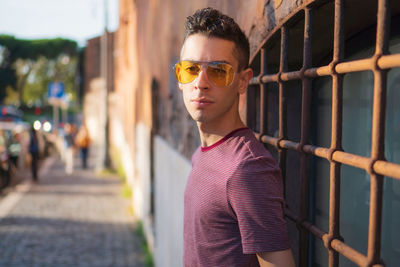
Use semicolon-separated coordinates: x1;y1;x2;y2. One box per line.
175;8;294;267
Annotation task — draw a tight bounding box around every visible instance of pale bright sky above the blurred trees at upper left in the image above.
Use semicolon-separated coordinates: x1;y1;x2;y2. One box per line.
0;0;118;46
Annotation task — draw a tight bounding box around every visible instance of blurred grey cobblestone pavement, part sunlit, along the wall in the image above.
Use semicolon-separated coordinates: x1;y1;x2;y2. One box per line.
0;158;144;267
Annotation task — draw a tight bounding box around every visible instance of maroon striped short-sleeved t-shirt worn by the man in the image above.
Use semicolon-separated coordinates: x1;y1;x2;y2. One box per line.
183;128;290;267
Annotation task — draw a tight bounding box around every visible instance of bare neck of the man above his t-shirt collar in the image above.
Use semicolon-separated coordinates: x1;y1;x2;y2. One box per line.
197;117;246;147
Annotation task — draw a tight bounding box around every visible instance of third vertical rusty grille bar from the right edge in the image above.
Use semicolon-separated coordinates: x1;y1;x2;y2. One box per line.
300;7;312;266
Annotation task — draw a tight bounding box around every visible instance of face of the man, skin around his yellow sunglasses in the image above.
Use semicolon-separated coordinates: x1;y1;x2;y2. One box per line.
179;34;247;124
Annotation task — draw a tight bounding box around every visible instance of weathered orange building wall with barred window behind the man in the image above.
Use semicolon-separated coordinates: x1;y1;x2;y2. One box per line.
85;0;400;267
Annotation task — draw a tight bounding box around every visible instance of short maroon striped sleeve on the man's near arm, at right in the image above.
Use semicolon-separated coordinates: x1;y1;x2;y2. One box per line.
227;157;290;254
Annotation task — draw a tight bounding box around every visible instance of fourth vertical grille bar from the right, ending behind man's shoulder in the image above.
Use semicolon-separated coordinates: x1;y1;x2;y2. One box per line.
278;26;288;194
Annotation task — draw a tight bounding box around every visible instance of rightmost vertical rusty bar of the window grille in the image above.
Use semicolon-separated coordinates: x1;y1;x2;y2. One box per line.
368;0;390;266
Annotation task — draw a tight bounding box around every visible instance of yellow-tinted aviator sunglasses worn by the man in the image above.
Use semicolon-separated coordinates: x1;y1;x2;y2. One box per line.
174;60;235;87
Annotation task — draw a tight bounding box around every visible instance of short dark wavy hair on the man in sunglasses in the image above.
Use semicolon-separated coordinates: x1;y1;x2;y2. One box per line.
184;7;250;70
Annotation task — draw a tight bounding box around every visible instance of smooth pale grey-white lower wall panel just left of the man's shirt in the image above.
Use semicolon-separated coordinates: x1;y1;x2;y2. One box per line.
154;136;191;267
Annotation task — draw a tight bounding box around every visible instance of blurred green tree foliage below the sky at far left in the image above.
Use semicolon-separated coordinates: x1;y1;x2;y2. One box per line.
0;35;78;104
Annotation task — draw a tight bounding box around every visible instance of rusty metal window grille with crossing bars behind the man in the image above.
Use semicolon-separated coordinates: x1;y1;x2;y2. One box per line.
247;0;400;266
